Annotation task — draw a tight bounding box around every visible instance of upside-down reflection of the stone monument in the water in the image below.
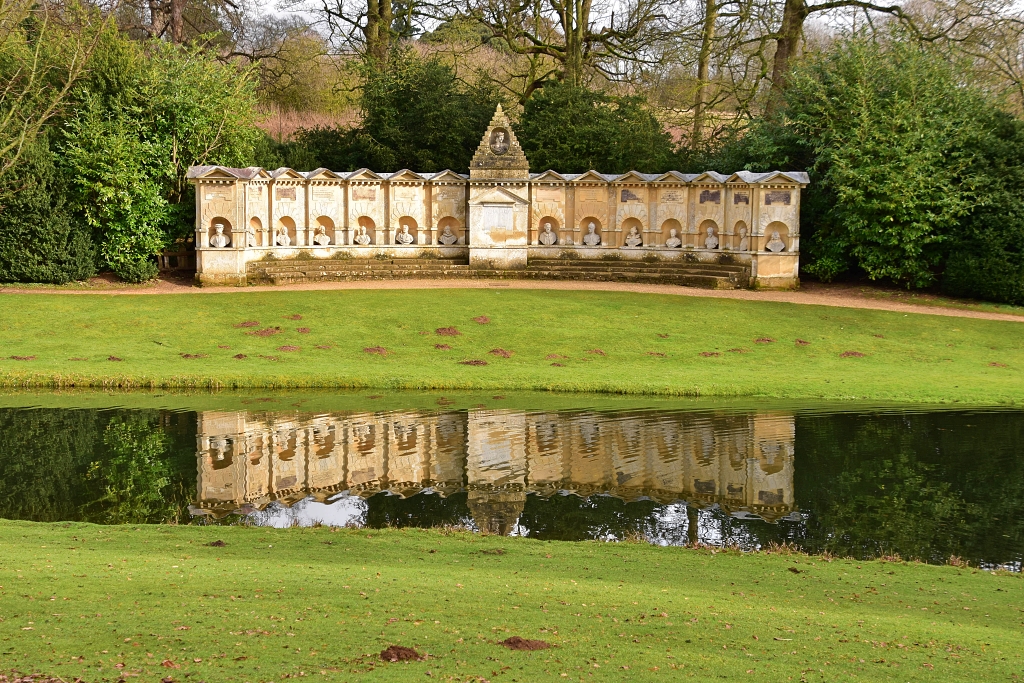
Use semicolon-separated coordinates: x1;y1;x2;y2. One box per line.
194;410;795;533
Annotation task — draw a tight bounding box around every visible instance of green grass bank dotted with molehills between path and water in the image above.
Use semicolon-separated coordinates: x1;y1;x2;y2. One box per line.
0;290;1024;403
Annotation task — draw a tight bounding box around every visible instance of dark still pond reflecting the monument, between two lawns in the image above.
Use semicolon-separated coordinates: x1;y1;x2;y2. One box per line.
0;392;1024;571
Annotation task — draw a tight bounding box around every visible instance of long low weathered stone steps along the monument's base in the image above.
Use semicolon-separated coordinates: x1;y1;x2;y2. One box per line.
247;258;750;289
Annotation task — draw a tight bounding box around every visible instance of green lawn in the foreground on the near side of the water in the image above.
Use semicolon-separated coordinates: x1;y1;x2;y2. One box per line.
0;522;1024;683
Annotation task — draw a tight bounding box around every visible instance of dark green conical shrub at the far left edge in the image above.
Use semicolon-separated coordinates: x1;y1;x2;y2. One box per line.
0;136;95;285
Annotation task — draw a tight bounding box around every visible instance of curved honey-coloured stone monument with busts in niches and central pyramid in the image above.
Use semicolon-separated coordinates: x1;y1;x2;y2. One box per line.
188;106;808;288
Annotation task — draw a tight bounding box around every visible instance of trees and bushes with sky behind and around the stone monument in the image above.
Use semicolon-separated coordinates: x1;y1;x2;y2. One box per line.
0;0;1024;304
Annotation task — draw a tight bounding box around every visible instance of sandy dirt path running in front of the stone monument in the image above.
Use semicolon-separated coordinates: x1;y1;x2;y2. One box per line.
0;279;1024;323
